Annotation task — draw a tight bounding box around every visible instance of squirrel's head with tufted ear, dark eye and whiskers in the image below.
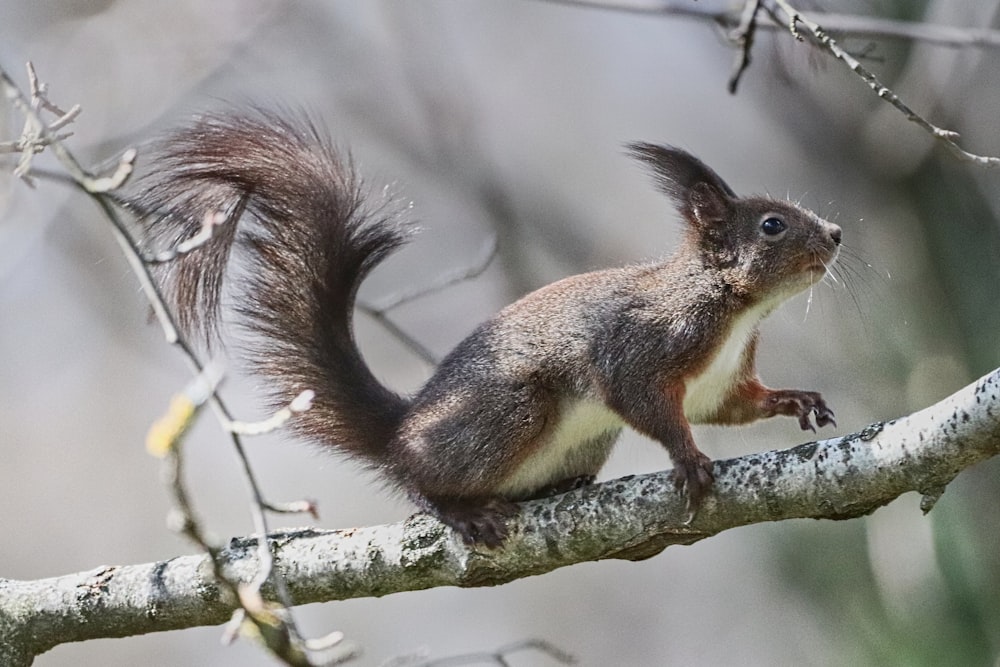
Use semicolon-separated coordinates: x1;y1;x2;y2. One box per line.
628;143;841;297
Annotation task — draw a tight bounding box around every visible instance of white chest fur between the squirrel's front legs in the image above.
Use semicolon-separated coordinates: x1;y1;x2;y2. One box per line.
684;303;774;423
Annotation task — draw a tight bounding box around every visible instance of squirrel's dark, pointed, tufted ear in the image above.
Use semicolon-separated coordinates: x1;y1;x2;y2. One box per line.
627;143;736;225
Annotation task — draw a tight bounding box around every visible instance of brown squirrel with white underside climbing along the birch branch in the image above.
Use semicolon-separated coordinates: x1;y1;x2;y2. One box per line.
127;109;841;547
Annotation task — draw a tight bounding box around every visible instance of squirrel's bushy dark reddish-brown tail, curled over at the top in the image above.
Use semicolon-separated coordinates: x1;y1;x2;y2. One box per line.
127;109;409;464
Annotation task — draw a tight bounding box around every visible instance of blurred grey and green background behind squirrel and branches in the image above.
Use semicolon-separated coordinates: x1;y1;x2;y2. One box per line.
0;0;1000;667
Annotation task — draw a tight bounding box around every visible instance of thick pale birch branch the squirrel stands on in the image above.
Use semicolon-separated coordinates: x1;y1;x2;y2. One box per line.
0;369;1000;665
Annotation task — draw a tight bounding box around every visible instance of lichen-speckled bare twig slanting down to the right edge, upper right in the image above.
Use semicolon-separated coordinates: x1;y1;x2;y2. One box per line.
774;0;1000;168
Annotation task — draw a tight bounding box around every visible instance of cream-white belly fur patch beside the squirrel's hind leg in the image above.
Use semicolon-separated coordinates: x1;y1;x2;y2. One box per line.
498;398;623;496
